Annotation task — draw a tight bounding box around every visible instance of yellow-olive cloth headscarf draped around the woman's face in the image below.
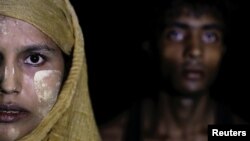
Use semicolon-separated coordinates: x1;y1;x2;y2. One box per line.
0;0;100;141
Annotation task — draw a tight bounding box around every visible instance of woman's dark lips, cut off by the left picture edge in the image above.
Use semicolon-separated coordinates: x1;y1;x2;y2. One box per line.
0;104;29;123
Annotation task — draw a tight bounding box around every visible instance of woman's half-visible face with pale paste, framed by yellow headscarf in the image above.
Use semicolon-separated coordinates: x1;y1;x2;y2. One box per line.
0;17;64;141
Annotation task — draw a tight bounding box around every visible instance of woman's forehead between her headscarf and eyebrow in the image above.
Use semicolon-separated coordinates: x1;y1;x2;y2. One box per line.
0;16;56;47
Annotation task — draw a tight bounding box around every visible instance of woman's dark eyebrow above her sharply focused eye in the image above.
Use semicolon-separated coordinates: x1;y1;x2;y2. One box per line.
20;44;55;52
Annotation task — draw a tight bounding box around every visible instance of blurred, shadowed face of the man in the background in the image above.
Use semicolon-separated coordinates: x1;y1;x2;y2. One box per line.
159;13;223;96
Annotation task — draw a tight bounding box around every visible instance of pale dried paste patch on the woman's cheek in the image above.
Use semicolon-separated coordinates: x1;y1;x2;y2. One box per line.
34;70;62;117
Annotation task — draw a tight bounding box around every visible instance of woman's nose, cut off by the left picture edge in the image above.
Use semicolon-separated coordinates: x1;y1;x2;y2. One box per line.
0;63;21;94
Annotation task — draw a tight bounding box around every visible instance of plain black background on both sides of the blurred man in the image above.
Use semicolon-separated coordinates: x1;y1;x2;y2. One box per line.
71;0;250;124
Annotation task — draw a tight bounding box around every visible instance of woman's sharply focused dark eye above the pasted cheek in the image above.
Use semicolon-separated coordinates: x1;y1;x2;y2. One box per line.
24;54;45;66
